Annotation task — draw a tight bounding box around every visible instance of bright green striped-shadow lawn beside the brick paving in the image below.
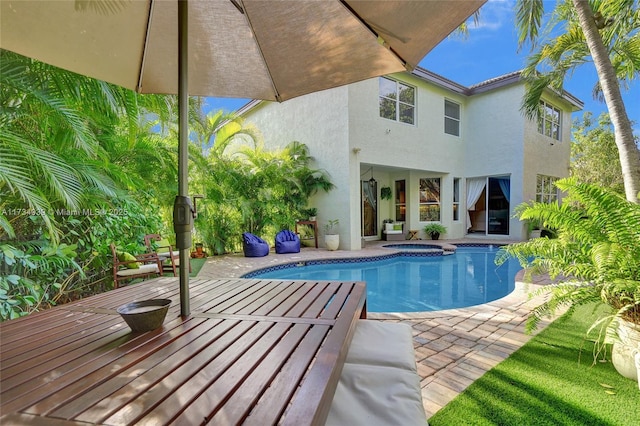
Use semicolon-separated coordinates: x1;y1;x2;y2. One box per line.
429;307;640;426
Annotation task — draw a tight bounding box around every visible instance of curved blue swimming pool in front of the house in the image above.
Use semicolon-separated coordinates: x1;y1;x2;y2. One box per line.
245;246;521;312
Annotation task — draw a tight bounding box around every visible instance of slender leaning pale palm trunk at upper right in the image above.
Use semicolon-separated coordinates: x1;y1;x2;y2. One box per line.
573;0;640;203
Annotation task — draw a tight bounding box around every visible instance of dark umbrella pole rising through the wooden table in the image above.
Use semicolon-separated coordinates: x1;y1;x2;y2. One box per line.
178;0;193;317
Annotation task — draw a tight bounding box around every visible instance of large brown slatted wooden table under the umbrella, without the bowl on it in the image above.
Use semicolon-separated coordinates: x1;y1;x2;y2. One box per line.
0;278;366;426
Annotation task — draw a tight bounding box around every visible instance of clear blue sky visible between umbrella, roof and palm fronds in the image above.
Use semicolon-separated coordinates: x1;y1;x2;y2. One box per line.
207;0;640;135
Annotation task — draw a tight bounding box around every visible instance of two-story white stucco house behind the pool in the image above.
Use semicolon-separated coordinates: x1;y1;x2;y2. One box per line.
239;68;582;250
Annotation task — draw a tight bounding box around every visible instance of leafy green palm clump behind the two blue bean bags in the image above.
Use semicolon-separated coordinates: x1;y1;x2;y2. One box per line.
191;134;333;254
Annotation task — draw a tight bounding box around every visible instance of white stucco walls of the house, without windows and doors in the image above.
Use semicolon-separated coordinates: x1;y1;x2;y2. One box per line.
245;73;571;250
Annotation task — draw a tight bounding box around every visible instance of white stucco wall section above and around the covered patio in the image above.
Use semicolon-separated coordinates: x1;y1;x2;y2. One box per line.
349;74;466;238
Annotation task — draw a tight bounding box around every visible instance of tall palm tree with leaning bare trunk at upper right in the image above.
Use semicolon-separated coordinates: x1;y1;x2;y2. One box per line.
516;0;640;203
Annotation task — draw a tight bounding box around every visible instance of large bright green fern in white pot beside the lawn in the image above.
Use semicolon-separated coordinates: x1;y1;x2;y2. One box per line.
496;178;640;380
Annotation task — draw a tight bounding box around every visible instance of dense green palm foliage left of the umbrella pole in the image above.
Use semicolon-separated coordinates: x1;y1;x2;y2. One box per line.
0;50;175;319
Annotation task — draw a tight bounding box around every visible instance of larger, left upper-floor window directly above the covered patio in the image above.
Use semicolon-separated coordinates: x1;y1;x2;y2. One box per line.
379;77;416;124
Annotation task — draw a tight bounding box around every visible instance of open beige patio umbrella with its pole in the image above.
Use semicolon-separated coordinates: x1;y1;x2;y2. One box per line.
0;0;486;315
